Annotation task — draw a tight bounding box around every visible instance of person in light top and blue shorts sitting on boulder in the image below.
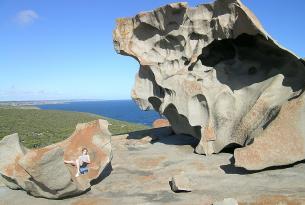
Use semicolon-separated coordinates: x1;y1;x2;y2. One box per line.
64;148;90;177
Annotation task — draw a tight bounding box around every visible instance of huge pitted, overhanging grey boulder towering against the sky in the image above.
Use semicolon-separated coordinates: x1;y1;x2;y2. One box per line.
113;0;305;166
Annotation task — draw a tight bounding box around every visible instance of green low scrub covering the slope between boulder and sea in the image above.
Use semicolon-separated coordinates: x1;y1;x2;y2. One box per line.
0;107;149;148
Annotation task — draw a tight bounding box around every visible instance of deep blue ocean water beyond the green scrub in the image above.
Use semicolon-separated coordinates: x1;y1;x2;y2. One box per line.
37;100;161;125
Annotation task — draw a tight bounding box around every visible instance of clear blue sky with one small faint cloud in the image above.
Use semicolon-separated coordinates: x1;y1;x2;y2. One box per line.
0;0;305;101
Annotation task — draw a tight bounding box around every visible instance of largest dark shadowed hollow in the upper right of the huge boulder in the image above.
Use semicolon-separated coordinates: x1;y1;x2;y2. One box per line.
197;34;305;92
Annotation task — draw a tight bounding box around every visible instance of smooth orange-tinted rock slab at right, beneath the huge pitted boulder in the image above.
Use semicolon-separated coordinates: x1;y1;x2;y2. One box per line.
234;94;305;170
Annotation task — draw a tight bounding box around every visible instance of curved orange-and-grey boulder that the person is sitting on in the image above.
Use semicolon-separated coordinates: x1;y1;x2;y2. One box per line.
0;120;112;199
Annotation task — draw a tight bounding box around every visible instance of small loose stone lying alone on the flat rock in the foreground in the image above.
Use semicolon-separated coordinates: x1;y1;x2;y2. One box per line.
169;174;192;193
